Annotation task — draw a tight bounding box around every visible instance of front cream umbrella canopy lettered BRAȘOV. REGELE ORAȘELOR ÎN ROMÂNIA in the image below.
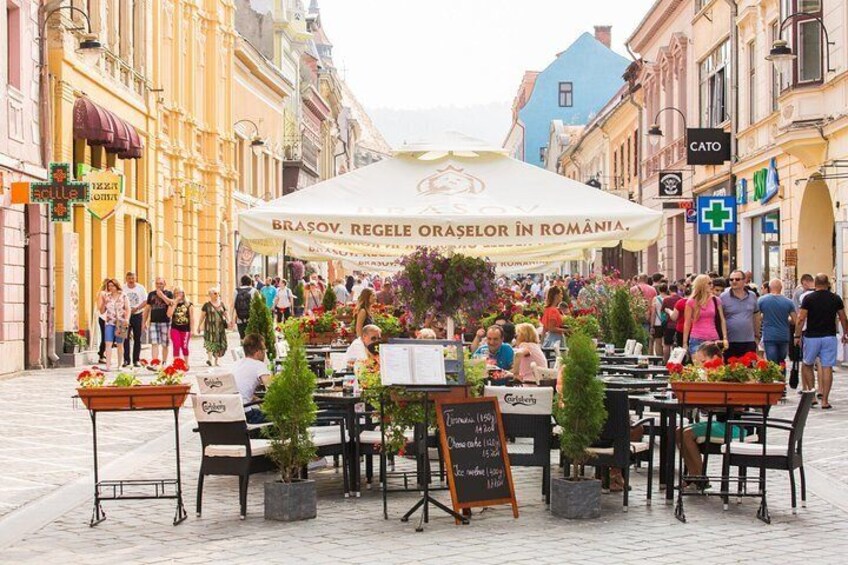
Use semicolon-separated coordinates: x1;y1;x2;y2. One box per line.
239;134;663;272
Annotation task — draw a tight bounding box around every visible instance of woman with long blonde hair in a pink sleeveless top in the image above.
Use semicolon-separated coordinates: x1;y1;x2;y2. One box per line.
683;275;727;355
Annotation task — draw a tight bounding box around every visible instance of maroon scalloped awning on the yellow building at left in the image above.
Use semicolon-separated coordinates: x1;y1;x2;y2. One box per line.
74;98;144;159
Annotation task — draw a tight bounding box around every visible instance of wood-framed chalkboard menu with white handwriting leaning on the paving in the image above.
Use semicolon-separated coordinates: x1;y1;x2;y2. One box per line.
436;398;518;518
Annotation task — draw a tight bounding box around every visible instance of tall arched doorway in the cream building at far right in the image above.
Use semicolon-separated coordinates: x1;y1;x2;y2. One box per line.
798;178;835;276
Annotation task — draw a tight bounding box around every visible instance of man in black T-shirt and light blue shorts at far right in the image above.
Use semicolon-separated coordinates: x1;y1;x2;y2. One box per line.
795;273;848;410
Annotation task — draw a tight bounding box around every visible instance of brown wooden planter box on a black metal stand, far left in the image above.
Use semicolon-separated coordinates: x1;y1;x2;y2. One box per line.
77;385;191;410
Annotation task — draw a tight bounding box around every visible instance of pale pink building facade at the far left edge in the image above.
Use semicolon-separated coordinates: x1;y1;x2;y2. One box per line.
0;0;49;375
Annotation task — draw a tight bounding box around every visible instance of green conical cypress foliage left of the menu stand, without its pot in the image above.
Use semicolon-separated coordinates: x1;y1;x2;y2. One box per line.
262;336;317;483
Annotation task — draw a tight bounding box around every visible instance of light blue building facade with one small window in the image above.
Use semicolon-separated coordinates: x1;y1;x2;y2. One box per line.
518;33;630;167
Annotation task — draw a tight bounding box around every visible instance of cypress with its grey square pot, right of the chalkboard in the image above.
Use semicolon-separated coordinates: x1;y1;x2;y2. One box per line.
551;332;607;519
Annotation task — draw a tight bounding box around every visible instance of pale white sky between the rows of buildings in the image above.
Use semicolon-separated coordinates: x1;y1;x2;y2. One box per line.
314;0;653;145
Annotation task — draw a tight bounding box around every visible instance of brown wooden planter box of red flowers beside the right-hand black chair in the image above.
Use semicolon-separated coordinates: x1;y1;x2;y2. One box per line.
671;382;785;406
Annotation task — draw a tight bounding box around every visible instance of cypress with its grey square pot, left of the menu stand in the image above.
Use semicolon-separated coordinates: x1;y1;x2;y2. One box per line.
262;335;318;522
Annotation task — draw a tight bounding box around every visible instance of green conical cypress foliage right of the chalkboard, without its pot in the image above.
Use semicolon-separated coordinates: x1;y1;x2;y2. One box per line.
554;332;607;480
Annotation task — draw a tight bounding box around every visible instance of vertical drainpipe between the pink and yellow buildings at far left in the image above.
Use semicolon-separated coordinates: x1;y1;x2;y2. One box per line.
38;3;59;367
